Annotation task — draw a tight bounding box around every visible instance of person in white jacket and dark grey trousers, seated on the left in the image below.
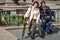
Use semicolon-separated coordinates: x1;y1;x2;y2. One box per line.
24;1;40;39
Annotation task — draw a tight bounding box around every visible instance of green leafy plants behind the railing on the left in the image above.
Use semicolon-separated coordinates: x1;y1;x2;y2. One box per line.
0;14;26;25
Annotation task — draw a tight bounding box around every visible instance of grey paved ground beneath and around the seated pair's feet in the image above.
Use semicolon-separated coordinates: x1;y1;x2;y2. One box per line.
8;28;60;40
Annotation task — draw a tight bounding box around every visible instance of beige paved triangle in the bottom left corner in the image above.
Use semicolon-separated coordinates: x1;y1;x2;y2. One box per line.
0;27;18;40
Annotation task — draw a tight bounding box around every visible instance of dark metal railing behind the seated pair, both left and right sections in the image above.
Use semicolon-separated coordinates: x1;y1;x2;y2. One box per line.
0;9;60;26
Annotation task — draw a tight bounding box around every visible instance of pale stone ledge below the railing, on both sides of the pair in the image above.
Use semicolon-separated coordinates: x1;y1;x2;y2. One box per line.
2;22;60;30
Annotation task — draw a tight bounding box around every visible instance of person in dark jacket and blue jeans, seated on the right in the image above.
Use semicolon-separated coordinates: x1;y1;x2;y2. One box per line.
39;1;52;35
